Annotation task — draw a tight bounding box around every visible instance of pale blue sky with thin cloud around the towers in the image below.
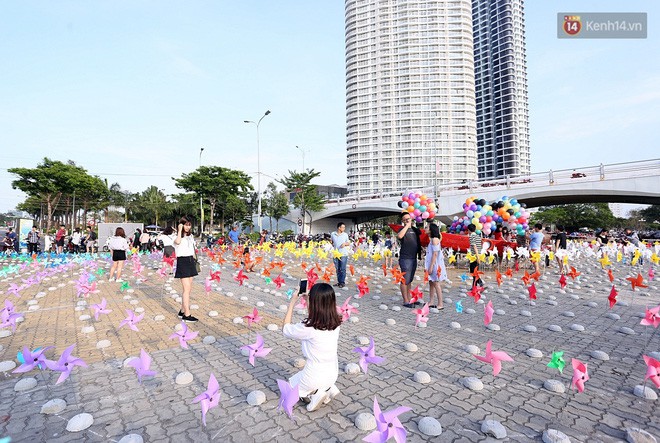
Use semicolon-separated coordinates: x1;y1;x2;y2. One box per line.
0;0;660;212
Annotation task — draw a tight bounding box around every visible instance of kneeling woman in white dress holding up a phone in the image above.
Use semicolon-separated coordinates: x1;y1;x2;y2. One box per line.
282;283;341;412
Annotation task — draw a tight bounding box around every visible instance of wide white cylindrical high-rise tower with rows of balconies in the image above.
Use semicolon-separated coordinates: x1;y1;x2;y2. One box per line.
345;0;477;194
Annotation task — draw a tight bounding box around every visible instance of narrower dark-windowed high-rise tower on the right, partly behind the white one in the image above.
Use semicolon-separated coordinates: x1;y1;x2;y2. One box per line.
472;0;530;179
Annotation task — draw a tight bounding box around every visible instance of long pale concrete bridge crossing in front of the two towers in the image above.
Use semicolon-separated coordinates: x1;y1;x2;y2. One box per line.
302;159;660;233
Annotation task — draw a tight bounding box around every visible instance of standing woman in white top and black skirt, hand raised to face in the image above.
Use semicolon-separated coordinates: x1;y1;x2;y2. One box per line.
174;216;197;322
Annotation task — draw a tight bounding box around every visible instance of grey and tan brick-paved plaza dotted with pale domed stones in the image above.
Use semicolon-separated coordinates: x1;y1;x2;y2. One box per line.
0;251;660;443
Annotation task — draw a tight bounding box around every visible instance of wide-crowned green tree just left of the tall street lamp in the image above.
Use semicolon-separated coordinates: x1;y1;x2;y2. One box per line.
172;166;253;236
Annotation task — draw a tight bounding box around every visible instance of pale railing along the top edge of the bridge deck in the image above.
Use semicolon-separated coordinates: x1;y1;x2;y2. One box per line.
326;159;660;206
